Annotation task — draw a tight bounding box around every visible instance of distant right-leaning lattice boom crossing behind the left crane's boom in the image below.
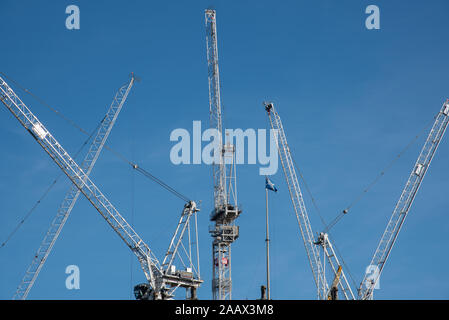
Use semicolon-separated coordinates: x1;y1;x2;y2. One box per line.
13;75;134;300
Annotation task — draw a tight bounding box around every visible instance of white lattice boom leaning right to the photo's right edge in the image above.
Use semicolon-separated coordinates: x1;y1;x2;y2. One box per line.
359;100;449;300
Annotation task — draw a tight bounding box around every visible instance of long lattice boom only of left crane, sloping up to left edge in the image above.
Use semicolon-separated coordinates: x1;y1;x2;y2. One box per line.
0;78;162;294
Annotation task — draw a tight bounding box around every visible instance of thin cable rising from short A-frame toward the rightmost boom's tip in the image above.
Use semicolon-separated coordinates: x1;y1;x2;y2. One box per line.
324;113;438;233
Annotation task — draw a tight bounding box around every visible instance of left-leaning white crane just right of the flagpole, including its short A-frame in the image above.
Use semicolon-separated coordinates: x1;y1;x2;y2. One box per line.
264;103;355;300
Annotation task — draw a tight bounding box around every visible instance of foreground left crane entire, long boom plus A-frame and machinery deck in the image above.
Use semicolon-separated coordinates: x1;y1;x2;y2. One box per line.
0;77;204;300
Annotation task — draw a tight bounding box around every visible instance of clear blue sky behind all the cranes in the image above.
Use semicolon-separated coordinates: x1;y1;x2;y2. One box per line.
0;0;449;299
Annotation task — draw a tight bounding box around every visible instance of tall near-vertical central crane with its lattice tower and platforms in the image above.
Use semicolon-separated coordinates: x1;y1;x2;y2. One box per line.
205;9;241;300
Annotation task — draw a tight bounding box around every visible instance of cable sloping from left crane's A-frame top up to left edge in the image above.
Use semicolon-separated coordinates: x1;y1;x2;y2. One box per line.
0;71;191;202
